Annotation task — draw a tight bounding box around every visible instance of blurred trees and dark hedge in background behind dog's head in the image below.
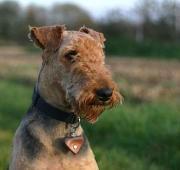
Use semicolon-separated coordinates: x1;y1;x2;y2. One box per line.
0;0;180;58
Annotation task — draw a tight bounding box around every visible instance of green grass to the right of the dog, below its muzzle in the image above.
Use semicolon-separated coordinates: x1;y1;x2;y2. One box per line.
84;103;180;170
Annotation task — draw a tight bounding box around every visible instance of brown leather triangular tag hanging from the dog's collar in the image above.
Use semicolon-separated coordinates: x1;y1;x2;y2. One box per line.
65;136;84;154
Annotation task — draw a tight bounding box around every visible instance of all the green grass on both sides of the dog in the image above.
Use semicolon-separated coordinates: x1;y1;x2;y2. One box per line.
0;80;180;170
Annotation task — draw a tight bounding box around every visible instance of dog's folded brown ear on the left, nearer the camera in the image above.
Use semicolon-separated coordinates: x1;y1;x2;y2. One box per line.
29;25;65;50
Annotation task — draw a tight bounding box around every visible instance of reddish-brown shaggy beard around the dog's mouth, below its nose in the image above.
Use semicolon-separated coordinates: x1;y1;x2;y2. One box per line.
73;92;122;123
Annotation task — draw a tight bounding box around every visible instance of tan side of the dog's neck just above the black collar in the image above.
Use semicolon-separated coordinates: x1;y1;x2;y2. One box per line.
37;62;73;112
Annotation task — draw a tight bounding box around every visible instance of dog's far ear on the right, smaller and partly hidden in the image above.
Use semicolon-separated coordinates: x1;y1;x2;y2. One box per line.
79;26;106;48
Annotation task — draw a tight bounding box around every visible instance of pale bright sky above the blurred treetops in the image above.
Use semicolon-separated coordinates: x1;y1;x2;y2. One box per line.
0;0;138;18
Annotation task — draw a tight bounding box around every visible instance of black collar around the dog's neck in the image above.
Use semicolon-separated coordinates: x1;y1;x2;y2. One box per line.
32;90;79;124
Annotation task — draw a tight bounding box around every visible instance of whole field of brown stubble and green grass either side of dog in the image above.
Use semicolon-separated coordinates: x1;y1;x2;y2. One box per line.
0;47;180;170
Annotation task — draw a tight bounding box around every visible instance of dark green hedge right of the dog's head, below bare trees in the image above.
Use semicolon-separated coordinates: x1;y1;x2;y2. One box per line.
106;37;180;59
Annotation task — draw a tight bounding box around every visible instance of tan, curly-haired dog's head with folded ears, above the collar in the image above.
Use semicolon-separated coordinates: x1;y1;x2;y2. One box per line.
30;26;122;122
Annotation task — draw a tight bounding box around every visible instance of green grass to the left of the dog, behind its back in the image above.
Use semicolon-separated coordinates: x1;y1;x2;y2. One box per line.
0;81;31;170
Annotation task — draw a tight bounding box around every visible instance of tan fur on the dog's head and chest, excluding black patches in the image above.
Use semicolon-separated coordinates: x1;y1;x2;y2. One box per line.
10;26;122;170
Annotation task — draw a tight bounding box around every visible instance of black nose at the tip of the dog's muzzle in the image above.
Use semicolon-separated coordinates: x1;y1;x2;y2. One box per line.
96;88;112;101
